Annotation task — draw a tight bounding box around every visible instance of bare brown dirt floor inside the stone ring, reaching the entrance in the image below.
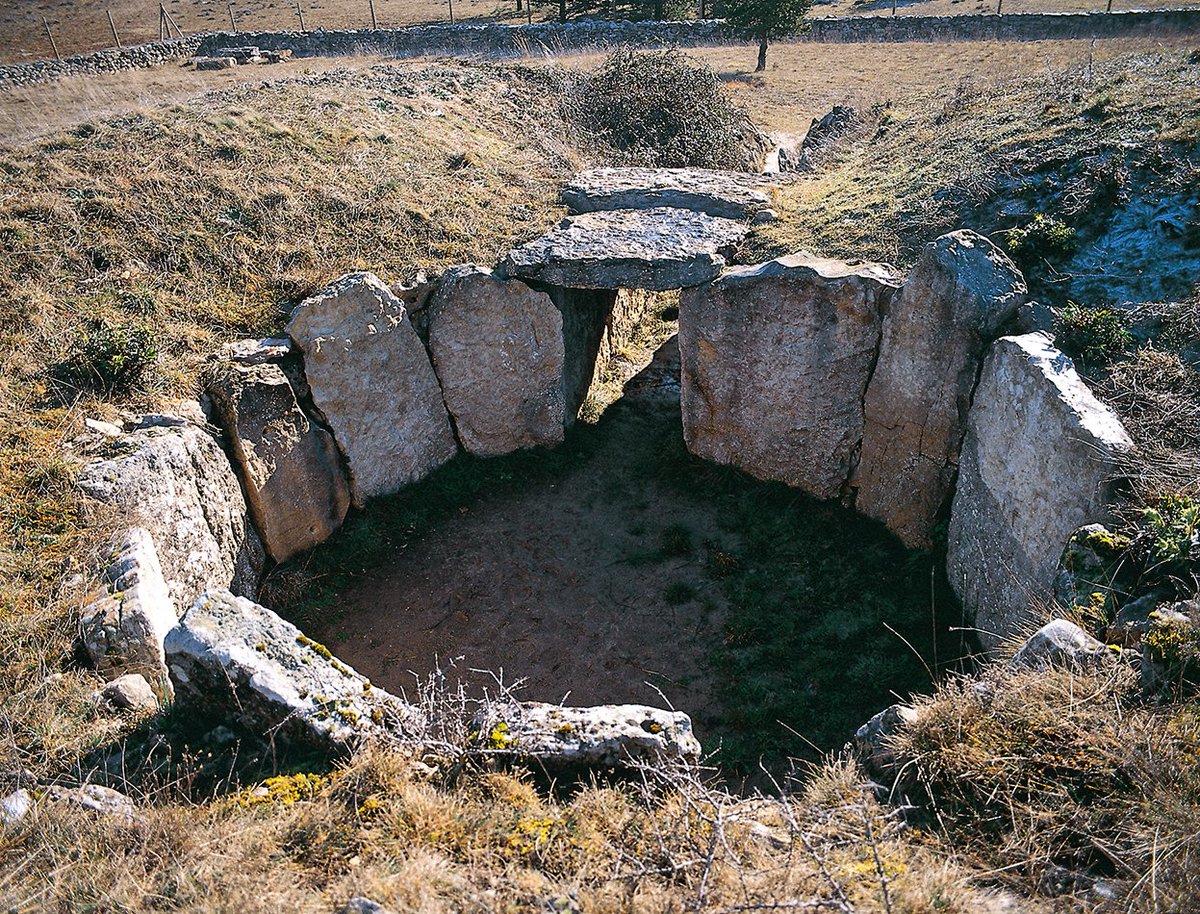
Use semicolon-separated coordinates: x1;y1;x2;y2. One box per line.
313;338;725;736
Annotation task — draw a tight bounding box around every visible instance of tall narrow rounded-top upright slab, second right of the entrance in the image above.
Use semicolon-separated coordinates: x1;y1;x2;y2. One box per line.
856;231;1025;548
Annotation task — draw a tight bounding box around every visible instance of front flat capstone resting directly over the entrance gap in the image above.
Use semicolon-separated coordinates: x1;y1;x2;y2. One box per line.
504;208;750;291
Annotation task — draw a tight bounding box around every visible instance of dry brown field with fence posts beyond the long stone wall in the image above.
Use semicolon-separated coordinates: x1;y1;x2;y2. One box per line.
0;0;1196;64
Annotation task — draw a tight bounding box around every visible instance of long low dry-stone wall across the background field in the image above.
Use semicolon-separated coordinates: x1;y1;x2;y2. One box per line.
0;10;1200;90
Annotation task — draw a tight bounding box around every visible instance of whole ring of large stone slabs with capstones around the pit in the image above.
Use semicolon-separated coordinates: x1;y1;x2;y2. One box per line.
79;169;1132;766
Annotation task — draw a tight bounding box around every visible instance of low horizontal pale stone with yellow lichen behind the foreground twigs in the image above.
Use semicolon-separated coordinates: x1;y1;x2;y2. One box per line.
479;702;701;768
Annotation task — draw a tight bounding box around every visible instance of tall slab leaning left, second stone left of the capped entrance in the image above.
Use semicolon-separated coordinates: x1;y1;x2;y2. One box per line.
288;272;457;505
